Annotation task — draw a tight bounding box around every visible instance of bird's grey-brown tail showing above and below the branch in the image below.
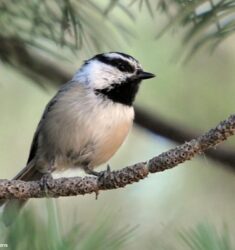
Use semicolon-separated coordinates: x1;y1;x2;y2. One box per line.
0;163;43;226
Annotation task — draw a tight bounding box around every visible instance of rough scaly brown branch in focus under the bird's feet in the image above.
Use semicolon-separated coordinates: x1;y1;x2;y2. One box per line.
0;114;235;199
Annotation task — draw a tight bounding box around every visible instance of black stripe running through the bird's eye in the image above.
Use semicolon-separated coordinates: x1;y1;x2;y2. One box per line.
93;54;135;73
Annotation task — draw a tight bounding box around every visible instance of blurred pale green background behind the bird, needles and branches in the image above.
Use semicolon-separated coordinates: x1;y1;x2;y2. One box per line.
0;0;235;250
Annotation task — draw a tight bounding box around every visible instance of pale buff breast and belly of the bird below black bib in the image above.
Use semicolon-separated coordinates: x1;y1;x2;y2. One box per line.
44;85;134;168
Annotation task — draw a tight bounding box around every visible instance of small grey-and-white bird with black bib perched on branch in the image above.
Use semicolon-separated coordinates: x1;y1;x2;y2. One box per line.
1;52;155;223
